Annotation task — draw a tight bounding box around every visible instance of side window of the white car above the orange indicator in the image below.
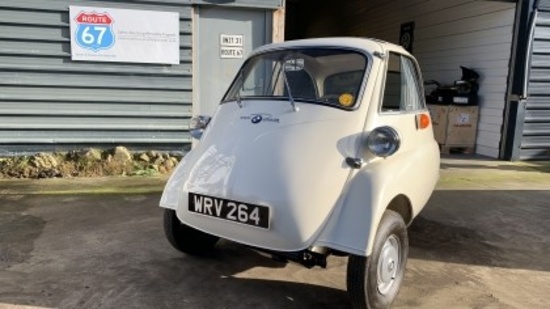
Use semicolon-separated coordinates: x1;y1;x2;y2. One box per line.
382;53;425;112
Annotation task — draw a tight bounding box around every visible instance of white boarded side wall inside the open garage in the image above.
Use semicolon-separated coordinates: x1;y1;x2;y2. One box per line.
346;0;515;158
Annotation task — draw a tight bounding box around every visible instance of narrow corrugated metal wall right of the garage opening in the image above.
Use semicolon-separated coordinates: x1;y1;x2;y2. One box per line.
520;0;550;159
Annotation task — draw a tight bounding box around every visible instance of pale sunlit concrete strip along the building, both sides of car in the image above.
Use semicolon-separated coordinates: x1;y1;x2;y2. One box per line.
0;155;550;194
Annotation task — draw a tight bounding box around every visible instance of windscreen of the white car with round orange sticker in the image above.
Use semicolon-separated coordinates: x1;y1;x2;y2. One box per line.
223;48;367;108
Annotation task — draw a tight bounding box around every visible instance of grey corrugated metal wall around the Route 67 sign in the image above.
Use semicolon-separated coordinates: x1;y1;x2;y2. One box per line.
0;0;192;155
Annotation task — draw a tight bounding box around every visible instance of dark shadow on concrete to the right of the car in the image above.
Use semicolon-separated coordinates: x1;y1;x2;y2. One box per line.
409;190;550;271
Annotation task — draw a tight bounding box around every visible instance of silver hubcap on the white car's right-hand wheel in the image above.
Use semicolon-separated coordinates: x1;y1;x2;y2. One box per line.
376;235;401;295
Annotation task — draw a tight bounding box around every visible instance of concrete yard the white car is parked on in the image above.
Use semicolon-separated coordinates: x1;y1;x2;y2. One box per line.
0;156;550;308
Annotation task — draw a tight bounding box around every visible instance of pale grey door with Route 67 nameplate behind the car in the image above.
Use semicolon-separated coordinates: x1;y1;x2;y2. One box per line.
193;6;272;116
